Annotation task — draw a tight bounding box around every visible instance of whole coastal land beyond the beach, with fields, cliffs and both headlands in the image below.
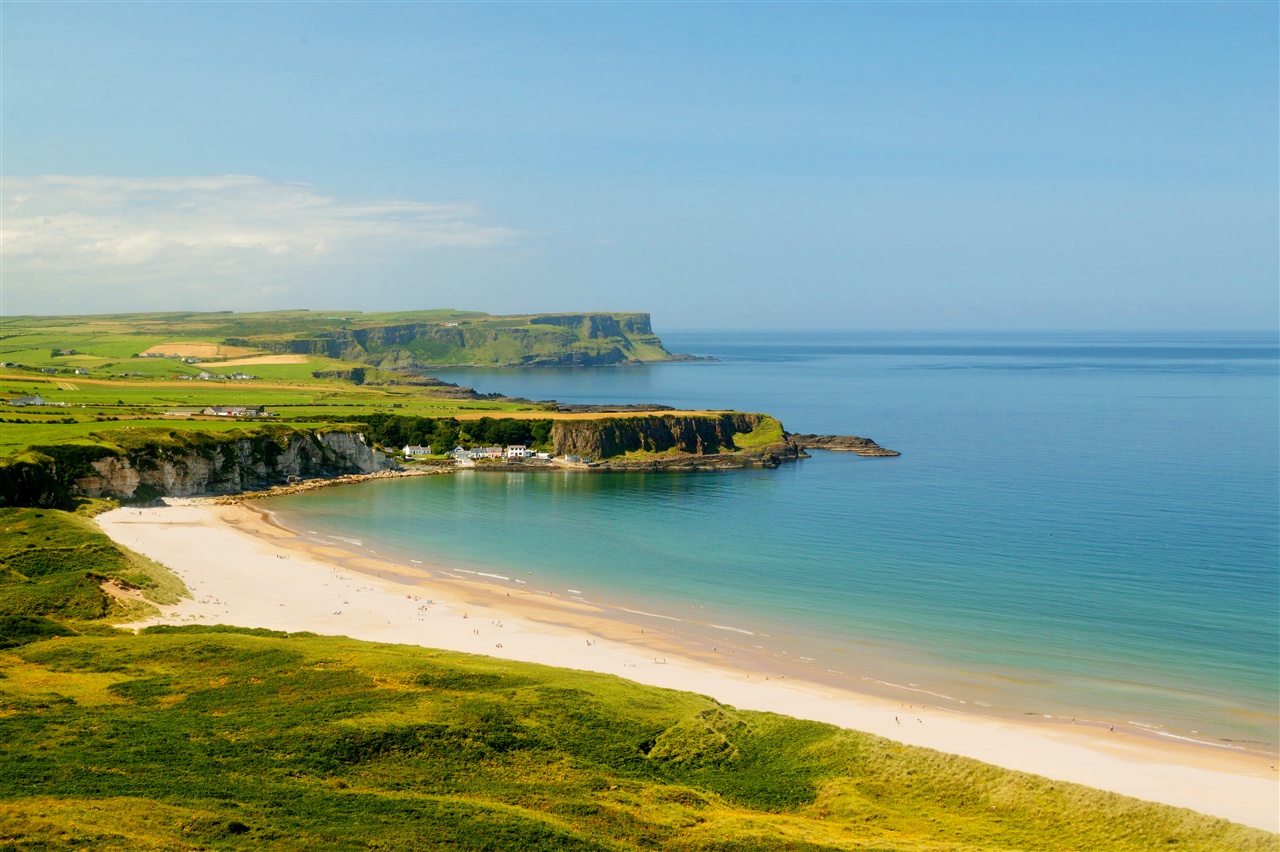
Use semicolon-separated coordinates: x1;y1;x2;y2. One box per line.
0;305;896;508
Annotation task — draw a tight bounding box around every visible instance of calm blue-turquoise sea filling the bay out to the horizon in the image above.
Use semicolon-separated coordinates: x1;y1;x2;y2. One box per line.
264;331;1280;746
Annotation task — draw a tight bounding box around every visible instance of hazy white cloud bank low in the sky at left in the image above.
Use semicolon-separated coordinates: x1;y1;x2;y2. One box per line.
0;175;516;313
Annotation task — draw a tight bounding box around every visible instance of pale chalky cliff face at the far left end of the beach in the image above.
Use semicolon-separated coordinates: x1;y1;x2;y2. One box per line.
70;432;394;499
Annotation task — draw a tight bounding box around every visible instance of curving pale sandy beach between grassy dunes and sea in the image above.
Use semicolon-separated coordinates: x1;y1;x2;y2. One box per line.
97;500;1280;832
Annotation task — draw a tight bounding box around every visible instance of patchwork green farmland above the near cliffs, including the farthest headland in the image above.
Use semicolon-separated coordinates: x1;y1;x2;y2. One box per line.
0;311;711;458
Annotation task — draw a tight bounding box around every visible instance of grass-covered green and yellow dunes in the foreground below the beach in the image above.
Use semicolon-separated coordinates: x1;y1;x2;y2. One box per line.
0;505;1280;852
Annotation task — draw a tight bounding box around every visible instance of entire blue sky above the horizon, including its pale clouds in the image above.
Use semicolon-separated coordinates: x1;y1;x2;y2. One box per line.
0;0;1280;330
